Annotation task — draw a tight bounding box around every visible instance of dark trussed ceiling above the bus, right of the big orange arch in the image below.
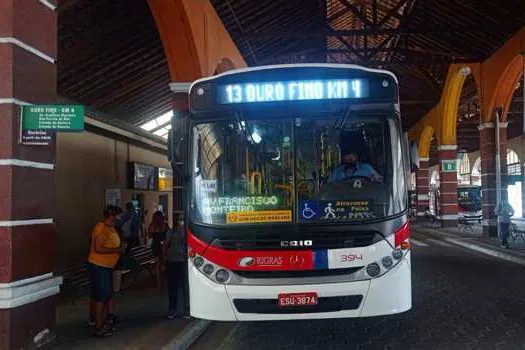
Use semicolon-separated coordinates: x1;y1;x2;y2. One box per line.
211;0;525;128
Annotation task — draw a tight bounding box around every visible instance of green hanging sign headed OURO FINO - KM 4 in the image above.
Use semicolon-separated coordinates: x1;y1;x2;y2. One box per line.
22;105;84;134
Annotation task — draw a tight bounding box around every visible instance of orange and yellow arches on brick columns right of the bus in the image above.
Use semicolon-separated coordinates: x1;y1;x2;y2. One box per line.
409;28;525;230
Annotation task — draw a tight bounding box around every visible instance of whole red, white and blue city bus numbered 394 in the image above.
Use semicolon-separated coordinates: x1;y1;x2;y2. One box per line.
171;64;412;321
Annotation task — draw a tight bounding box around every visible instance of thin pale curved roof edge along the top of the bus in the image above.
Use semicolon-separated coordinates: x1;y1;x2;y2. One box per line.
189;63;399;93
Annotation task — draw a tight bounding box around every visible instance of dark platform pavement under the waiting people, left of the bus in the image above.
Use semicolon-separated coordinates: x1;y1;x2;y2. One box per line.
50;276;199;350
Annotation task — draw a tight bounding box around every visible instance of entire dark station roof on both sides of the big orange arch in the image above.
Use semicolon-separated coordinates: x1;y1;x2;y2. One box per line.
58;0;525;151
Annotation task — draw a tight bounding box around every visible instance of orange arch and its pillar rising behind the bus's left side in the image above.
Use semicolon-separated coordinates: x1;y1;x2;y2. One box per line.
148;0;246;322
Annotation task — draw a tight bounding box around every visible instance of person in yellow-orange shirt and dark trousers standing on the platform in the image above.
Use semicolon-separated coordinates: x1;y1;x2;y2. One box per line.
88;205;125;337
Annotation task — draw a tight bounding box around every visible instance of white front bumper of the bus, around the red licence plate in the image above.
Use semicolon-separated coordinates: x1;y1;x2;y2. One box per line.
189;253;412;321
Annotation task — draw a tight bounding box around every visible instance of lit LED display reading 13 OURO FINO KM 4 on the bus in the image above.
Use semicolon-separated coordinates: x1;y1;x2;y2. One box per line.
217;79;369;104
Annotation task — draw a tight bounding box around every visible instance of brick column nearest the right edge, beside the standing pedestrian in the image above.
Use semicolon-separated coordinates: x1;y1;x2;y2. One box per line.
478;123;507;237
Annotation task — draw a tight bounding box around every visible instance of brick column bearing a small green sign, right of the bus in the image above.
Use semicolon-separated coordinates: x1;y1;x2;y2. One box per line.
438;145;458;226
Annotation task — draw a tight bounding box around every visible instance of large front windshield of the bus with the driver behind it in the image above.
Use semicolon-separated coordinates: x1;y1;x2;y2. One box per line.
190;114;406;225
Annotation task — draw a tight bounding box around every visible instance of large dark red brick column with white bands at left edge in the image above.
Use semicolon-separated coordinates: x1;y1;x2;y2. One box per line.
0;0;61;349
